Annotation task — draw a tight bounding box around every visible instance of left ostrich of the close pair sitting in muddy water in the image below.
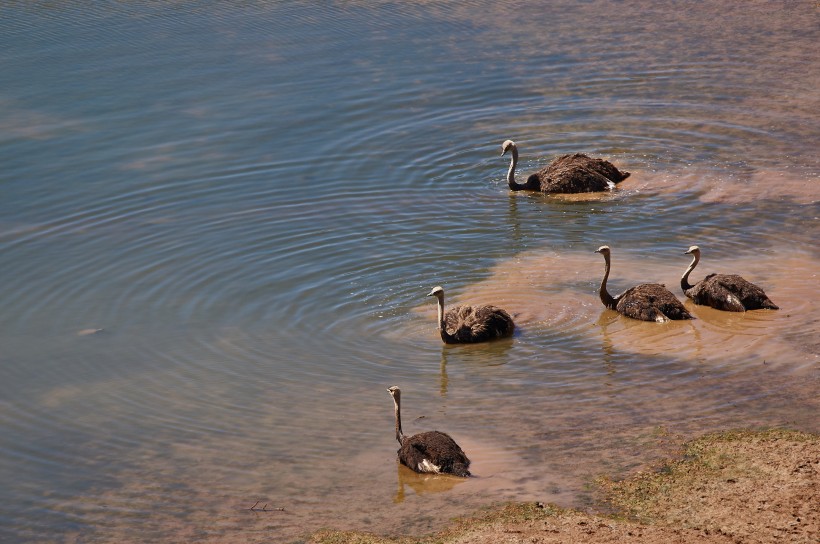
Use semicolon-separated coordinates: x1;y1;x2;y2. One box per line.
595;246;692;322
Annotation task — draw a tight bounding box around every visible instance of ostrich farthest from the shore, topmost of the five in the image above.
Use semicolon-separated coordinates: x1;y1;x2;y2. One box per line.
501;140;629;193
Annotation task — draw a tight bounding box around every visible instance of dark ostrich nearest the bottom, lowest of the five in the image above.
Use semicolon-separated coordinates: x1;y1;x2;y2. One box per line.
387;385;470;476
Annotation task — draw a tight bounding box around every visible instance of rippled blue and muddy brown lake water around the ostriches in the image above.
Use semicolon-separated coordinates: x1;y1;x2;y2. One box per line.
0;0;820;542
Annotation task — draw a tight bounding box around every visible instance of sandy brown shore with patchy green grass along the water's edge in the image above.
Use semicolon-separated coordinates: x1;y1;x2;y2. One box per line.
307;430;820;544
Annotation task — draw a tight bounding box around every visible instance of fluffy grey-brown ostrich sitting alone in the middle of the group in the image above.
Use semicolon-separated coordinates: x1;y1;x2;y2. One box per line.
427;287;515;344
